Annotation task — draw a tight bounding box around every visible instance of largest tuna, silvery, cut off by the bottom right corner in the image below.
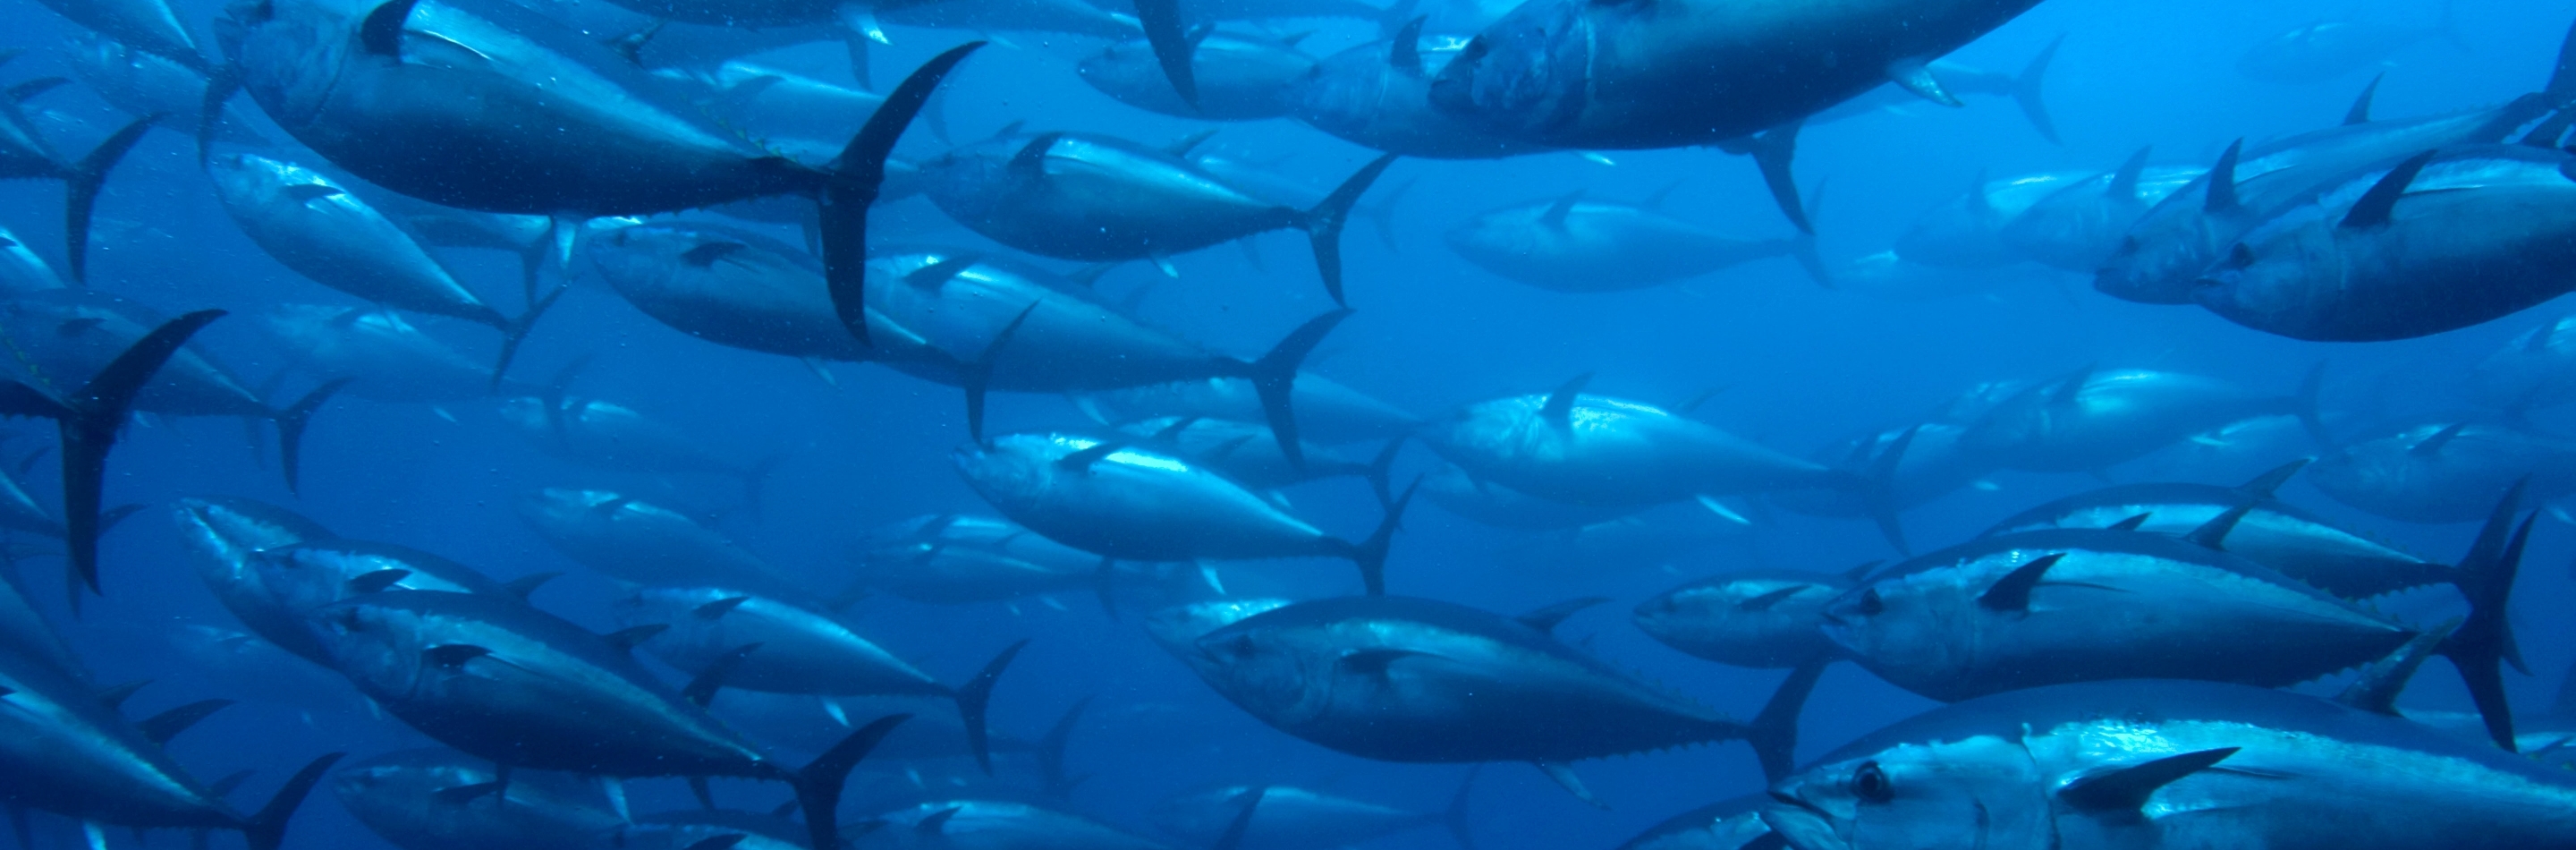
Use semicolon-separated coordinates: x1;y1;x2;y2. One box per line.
1762;680;2576;850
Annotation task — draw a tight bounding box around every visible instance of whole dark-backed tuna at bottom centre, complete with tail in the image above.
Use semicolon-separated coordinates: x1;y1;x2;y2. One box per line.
1198;595;1821;798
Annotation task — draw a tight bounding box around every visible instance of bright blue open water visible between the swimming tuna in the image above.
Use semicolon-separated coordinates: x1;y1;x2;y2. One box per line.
0;0;2576;847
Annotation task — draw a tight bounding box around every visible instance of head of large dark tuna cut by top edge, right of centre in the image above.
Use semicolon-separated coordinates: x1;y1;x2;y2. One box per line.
1429;0;1595;137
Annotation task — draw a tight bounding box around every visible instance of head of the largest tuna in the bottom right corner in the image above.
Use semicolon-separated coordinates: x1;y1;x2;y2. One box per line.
1762;734;2055;850
